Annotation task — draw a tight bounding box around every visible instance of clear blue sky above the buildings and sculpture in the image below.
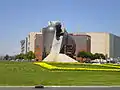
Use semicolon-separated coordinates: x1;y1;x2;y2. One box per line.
0;0;120;55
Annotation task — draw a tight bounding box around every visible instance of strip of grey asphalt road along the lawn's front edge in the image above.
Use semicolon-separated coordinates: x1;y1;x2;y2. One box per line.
0;87;120;90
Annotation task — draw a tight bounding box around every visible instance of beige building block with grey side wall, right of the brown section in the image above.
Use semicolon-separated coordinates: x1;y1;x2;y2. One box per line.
86;32;120;57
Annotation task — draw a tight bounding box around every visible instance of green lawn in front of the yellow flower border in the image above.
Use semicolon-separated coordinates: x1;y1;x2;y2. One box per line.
0;62;120;86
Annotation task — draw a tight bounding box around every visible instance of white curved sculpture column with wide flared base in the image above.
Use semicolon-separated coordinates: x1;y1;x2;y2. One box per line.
43;21;77;62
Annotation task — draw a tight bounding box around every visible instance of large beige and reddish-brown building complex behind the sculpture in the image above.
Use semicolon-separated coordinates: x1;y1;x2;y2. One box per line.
20;28;120;60
